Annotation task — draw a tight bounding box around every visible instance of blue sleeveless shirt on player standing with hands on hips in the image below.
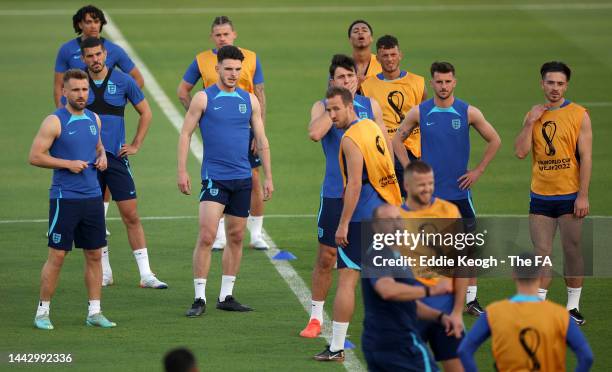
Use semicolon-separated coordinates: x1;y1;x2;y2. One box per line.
419;98;470;200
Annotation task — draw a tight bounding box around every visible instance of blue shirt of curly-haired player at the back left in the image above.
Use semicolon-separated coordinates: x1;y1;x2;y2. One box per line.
55;36;136;73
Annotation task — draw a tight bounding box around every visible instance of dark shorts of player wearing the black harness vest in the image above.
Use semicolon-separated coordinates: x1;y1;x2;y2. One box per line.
98;152;136;201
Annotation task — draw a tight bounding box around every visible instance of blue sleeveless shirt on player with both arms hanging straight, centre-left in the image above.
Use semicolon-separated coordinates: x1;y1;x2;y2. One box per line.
200;84;252;180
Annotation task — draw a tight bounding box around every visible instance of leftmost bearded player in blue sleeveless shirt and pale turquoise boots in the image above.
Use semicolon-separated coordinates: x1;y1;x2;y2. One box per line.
29;69;116;330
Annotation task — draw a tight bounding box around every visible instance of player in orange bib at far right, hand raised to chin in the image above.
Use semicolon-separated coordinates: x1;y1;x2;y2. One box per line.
515;62;593;325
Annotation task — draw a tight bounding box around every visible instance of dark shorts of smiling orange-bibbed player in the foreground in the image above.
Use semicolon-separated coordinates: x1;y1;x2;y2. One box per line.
418;294;463;362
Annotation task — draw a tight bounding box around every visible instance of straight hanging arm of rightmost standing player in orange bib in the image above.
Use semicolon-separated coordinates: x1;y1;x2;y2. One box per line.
574;112;593;218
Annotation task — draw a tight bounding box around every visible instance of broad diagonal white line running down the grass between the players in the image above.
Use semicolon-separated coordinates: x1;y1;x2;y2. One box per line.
106;13;365;371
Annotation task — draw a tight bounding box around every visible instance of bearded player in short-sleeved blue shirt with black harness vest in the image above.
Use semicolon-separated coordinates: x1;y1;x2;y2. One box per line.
81;38;168;289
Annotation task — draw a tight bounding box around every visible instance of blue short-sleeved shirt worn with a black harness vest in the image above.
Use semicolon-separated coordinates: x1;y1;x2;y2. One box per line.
87;69;145;156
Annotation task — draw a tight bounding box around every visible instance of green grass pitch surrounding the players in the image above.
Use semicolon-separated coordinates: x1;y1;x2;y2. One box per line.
0;0;612;371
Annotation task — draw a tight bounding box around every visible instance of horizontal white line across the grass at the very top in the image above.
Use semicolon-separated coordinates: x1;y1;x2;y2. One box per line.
0;3;612;16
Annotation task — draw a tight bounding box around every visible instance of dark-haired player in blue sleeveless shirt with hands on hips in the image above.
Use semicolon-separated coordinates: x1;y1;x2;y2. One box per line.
393;62;501;316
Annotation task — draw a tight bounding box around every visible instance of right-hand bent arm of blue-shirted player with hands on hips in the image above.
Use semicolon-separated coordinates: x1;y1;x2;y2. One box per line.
457;106;501;190
